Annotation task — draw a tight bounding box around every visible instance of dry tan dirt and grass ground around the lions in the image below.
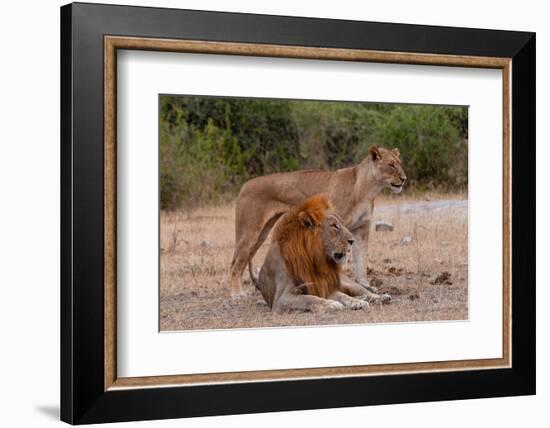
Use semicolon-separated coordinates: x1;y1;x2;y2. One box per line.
160;195;468;331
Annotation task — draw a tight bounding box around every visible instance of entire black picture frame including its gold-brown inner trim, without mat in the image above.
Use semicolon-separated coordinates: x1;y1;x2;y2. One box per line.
61;3;536;424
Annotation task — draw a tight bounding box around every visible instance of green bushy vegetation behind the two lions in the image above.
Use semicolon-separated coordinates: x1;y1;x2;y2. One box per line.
159;96;468;209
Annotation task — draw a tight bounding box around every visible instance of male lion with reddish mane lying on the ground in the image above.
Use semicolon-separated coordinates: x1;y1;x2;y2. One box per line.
252;195;391;313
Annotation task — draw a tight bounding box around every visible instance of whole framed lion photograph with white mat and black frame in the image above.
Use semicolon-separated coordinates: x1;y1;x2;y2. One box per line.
61;3;535;424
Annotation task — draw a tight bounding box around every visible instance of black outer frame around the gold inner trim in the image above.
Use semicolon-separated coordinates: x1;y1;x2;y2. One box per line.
61;3;535;424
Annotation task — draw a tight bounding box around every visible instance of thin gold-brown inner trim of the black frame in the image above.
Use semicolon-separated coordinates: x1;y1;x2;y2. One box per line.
104;36;512;391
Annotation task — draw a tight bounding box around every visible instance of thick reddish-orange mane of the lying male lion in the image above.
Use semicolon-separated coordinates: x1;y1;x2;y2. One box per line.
273;195;340;298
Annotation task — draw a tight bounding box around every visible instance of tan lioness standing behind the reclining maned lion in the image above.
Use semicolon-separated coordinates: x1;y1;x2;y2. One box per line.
231;146;407;298
